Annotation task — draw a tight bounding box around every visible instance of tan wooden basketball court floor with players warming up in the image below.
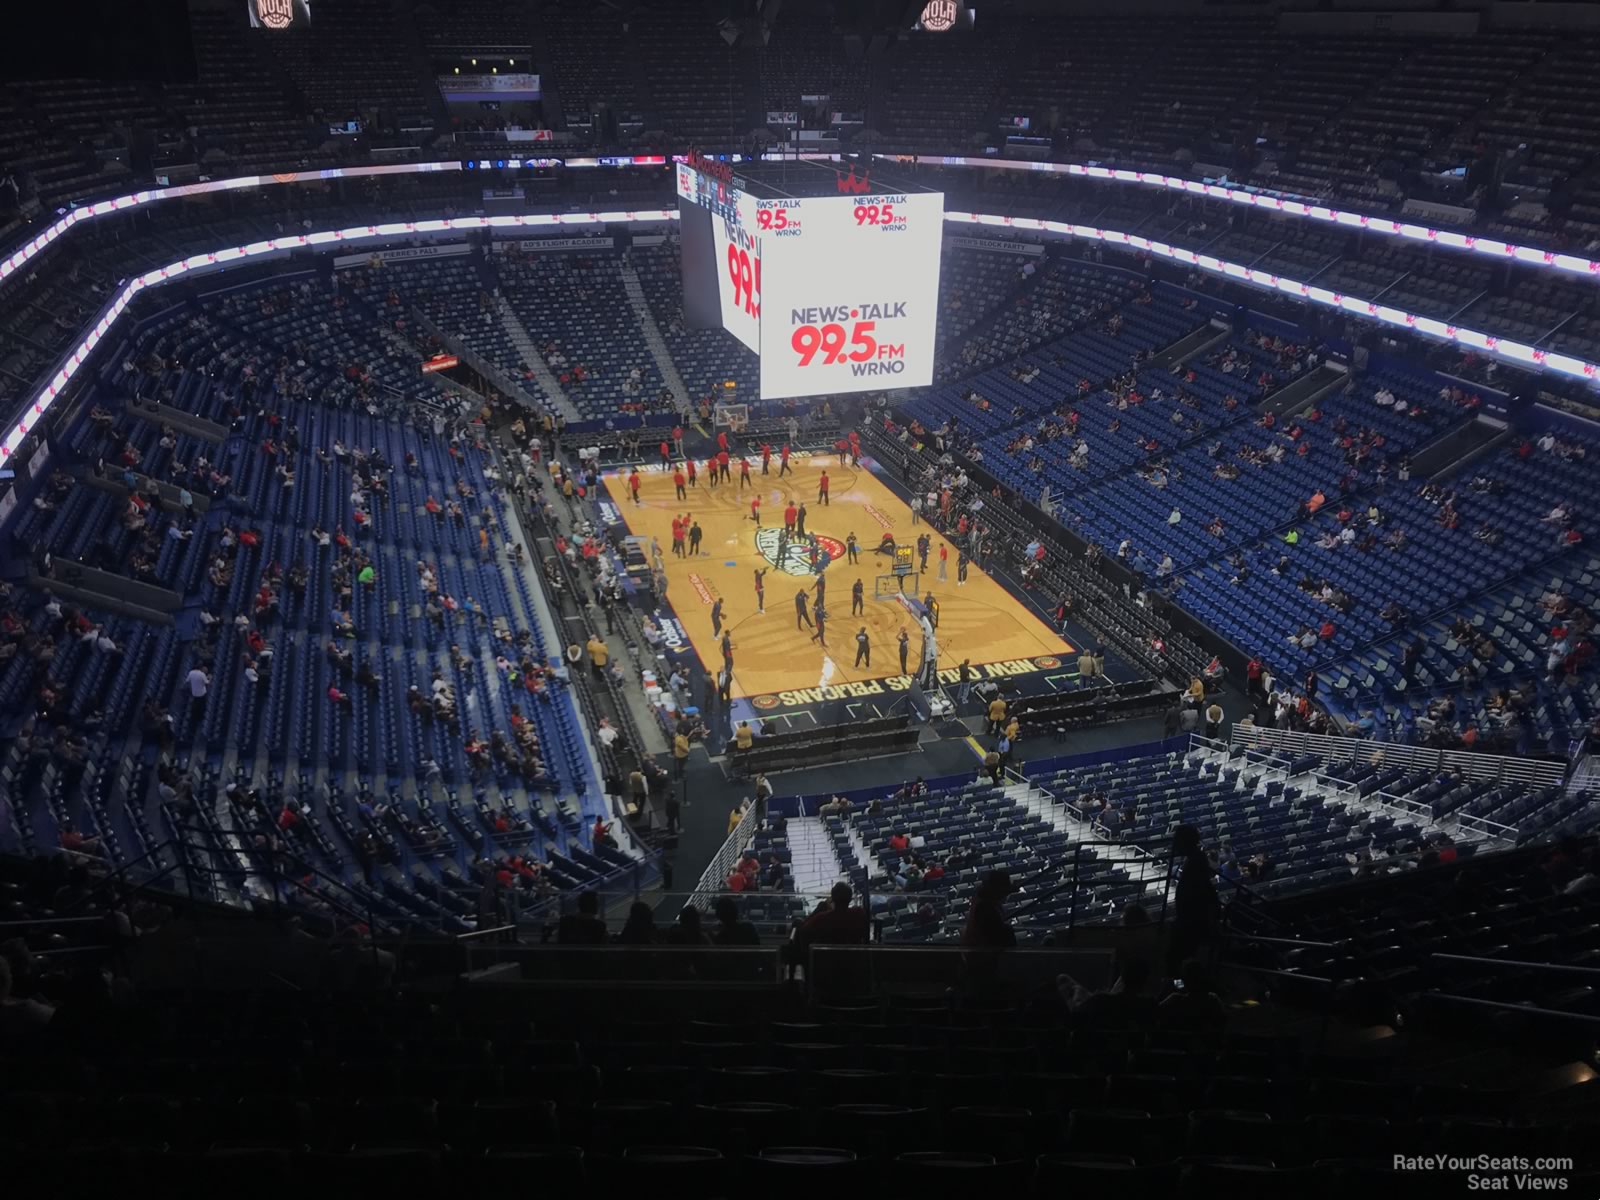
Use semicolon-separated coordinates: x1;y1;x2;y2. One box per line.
605;453;1075;709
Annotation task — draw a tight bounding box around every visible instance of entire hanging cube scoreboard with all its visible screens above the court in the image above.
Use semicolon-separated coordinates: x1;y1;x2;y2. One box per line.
677;163;944;400
